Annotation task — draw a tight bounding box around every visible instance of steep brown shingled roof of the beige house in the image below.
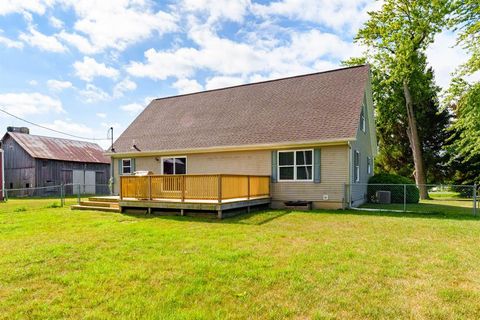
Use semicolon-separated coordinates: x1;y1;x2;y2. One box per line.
114;66;369;153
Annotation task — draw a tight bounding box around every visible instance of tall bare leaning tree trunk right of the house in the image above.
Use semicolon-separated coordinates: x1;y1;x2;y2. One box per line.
403;80;429;200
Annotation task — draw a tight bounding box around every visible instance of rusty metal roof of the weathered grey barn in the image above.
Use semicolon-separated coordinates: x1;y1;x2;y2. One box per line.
4;132;110;163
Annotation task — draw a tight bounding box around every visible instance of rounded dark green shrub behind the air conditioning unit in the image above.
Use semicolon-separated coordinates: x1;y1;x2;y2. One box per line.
367;173;420;203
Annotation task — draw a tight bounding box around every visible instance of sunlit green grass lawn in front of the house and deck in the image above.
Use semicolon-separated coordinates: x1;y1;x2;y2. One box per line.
0;200;480;319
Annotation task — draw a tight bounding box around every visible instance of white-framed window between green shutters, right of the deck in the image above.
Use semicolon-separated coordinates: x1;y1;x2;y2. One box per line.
278;150;313;181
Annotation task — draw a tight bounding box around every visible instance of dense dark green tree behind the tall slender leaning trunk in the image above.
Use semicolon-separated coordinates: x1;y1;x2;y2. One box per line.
343;57;450;183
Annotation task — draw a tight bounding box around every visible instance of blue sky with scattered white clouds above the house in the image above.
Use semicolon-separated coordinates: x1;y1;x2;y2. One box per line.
0;0;474;147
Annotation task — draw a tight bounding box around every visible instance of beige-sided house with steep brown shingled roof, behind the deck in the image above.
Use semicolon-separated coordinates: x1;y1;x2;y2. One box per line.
108;65;377;214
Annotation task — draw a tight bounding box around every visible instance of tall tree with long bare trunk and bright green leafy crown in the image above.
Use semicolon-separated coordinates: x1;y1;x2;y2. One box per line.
356;0;450;199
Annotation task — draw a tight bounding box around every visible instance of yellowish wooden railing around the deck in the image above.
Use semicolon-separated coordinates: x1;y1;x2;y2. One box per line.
120;174;270;202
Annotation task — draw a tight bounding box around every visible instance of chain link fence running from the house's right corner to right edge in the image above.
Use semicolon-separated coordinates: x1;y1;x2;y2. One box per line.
345;183;480;216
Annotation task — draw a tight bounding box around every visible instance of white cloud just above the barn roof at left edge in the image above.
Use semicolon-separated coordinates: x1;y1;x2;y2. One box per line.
0;93;64;117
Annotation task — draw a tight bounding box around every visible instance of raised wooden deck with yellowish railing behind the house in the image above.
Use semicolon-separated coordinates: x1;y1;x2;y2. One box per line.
118;174;270;219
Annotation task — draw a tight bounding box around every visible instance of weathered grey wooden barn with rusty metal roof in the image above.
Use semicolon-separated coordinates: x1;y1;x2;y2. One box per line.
2;127;110;196
